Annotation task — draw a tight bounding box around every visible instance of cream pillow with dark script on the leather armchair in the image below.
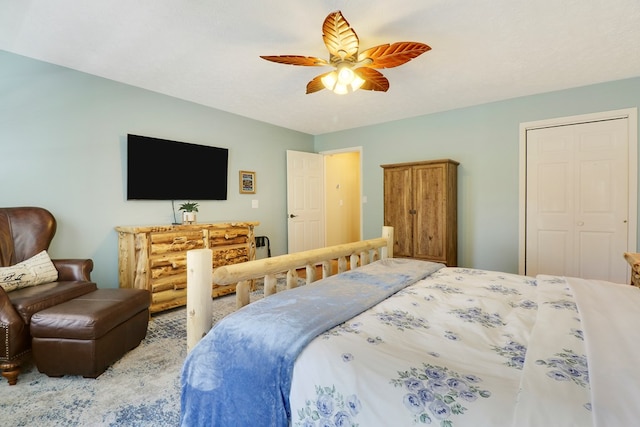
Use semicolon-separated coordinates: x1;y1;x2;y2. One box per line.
0;251;58;292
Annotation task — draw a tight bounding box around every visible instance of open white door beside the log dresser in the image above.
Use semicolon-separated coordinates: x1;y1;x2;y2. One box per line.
287;150;324;253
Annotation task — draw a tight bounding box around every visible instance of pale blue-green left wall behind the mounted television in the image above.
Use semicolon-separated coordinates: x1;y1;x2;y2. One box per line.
0;51;313;287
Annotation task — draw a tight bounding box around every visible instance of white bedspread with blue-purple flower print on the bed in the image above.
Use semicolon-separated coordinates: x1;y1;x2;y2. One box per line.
290;268;638;427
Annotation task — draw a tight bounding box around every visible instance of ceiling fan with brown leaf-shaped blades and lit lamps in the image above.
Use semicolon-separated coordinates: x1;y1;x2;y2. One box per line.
260;10;431;94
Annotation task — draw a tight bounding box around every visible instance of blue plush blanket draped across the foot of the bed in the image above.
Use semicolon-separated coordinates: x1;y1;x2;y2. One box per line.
181;258;443;427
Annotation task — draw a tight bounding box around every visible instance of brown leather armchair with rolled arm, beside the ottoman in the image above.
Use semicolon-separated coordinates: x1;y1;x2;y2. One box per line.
0;207;97;385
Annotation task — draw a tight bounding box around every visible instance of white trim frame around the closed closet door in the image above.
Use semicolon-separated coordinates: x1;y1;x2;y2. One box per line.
518;108;638;274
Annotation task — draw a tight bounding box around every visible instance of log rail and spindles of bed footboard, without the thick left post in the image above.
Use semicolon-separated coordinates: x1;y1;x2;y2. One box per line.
213;227;393;308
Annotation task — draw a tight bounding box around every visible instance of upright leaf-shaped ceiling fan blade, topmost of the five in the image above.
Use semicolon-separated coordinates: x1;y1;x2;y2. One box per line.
322;10;360;64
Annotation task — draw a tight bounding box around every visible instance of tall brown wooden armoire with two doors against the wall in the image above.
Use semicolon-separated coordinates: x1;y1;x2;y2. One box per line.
382;159;459;266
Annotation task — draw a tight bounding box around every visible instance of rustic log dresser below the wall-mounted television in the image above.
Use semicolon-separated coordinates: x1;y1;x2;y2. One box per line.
116;222;259;313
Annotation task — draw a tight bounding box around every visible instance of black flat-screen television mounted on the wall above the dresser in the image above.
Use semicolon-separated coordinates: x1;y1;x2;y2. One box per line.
127;134;229;200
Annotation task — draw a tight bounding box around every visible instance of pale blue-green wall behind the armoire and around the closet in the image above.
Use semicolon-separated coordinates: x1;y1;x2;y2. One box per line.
315;77;640;273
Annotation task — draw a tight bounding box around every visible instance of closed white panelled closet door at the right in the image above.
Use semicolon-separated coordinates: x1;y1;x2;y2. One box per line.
525;118;635;283
